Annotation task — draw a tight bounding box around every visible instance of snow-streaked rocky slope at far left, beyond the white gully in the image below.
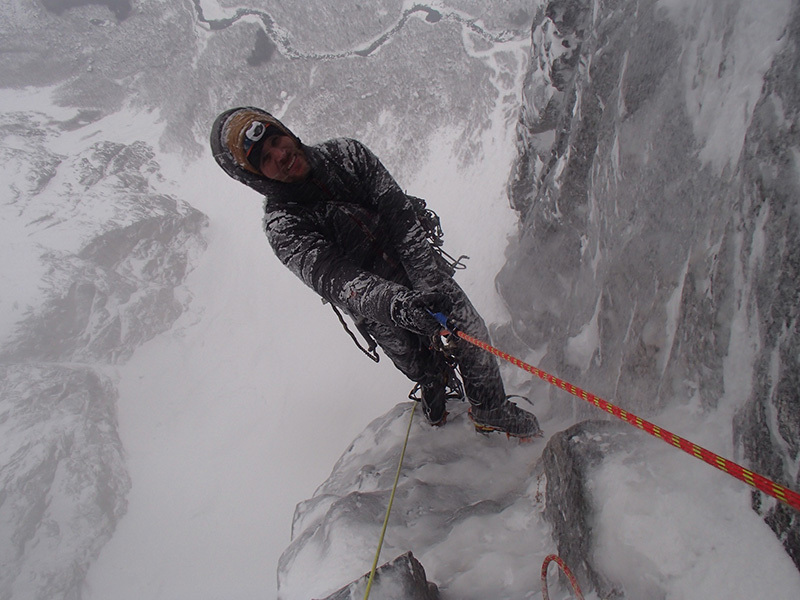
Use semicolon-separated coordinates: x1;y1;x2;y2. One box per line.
0;112;206;600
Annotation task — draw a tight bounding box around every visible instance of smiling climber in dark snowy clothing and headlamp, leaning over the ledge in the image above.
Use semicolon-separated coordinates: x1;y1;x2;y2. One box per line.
211;107;540;438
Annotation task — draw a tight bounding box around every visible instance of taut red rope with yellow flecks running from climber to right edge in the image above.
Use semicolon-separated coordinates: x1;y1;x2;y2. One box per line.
456;331;800;511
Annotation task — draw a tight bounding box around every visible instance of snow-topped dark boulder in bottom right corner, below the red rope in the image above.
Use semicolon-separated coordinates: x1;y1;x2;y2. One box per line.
543;420;800;600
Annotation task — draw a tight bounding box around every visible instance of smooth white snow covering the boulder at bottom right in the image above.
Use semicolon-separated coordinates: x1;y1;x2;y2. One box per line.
593;440;800;600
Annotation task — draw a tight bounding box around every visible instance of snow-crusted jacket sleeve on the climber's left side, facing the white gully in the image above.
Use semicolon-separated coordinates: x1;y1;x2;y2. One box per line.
264;203;408;325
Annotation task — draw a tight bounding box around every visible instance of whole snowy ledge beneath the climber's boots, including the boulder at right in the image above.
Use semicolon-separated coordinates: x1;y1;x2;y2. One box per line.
278;403;800;600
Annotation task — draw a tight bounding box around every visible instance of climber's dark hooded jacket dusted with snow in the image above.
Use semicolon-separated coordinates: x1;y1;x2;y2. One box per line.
211;109;449;324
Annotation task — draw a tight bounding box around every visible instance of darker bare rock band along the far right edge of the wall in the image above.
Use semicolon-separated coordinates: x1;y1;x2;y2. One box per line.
736;10;800;568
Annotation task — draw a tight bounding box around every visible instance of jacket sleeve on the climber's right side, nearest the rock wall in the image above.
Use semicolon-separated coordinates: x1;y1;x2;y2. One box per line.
342;140;444;291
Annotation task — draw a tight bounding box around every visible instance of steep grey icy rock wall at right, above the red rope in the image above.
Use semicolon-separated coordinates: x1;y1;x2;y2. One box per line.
497;0;800;567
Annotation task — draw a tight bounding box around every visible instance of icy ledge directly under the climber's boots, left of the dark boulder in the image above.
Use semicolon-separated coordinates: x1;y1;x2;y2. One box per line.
278;403;554;600
